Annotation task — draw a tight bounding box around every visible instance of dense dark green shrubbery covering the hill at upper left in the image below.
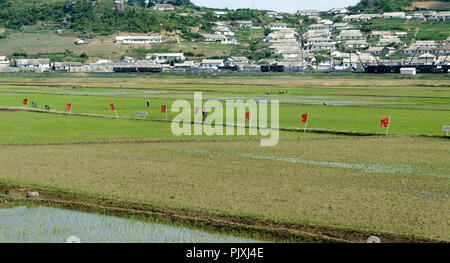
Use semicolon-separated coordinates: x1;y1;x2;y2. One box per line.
0;0;199;34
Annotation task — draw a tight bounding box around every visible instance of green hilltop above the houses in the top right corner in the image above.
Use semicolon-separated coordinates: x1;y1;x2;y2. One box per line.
351;0;450;13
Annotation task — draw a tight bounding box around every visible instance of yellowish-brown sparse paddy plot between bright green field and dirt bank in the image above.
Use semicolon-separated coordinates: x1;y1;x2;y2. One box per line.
0;137;450;241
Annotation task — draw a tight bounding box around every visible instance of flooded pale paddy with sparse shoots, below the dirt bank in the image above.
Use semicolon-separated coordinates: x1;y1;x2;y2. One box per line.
0;206;261;243
